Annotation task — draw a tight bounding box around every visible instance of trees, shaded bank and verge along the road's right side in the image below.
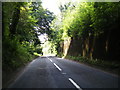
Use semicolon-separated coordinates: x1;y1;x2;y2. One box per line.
50;2;120;75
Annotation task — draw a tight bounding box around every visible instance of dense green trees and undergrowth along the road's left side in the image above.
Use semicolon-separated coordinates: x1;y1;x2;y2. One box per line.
2;2;54;71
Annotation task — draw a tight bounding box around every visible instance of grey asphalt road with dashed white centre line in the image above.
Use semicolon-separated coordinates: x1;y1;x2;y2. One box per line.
9;57;119;90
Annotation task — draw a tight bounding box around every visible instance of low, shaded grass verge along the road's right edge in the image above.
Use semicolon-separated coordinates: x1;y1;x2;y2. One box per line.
65;56;120;76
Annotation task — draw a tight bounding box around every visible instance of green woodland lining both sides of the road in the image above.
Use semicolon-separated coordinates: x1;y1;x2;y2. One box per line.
2;2;120;74
